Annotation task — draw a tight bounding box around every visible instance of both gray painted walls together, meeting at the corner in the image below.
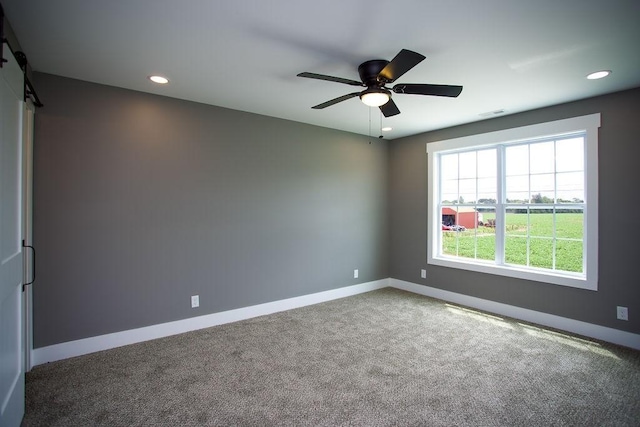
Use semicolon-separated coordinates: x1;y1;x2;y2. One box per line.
34;73;640;348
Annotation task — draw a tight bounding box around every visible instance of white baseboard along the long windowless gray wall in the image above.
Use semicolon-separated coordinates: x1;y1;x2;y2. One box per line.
30;279;389;368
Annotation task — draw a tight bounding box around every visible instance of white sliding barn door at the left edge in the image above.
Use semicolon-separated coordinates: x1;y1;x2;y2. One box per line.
0;45;24;427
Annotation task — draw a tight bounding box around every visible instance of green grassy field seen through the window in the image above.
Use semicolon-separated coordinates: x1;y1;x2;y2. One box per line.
442;212;584;272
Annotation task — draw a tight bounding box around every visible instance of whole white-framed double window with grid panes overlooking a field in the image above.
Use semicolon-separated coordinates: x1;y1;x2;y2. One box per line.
427;114;600;290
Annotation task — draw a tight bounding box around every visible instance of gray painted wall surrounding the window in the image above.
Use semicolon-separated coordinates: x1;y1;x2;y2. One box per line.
389;89;640;333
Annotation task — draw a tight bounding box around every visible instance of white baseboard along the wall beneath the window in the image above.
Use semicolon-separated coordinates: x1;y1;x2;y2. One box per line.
389;279;640;350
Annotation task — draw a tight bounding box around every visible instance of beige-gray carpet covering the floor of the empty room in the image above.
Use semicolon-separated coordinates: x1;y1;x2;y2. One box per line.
23;289;640;426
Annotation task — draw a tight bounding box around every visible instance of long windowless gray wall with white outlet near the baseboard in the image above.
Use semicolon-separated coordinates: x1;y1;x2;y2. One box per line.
33;73;389;348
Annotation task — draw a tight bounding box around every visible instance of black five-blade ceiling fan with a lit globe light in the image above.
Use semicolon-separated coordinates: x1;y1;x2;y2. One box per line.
298;49;462;117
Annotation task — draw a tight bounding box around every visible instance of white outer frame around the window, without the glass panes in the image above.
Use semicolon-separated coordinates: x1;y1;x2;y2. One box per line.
427;113;600;291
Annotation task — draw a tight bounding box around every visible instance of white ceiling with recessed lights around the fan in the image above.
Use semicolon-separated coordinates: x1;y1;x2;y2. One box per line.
0;0;640;139
